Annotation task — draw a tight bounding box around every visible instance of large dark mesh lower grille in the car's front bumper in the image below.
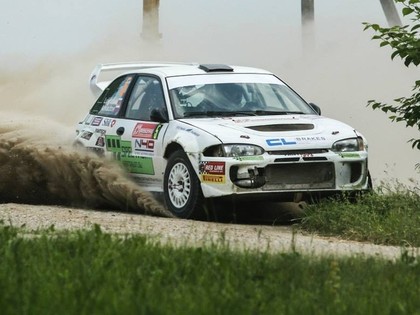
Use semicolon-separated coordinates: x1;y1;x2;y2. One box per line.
262;162;335;191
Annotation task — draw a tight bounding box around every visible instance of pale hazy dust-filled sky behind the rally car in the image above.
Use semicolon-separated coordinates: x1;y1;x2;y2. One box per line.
0;0;420;183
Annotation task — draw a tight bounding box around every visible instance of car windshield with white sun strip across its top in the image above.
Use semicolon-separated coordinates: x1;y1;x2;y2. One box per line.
168;74;315;118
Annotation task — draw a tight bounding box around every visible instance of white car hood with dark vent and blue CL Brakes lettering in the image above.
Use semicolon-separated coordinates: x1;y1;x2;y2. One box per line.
181;115;361;150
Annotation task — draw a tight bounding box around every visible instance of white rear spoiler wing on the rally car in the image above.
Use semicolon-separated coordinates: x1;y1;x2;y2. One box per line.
89;62;196;98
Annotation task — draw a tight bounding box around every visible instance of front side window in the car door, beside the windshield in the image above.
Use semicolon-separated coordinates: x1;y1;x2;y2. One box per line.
125;76;165;121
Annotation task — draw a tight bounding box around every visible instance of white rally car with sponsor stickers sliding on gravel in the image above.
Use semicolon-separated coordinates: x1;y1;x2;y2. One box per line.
75;63;371;218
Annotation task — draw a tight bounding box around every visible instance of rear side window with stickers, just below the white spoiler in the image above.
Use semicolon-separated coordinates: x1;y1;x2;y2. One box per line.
90;75;134;117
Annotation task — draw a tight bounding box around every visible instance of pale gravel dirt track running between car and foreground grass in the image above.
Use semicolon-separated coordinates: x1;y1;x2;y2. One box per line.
0;203;419;260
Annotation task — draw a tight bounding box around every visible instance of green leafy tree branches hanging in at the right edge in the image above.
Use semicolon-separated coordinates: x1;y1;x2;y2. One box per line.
363;0;420;150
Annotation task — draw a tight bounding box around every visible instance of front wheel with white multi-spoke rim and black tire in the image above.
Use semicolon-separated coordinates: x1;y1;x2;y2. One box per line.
163;151;205;219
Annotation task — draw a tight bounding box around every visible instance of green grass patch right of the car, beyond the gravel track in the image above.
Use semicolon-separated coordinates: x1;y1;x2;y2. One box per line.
300;185;420;247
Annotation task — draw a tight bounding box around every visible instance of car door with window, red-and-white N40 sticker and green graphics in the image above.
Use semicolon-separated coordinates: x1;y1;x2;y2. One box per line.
106;75;167;191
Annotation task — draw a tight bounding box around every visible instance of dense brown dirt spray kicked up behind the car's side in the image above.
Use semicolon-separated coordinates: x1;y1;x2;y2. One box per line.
0;112;171;217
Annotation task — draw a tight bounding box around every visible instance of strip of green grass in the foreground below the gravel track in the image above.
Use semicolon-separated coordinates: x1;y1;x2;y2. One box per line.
0;224;420;314
